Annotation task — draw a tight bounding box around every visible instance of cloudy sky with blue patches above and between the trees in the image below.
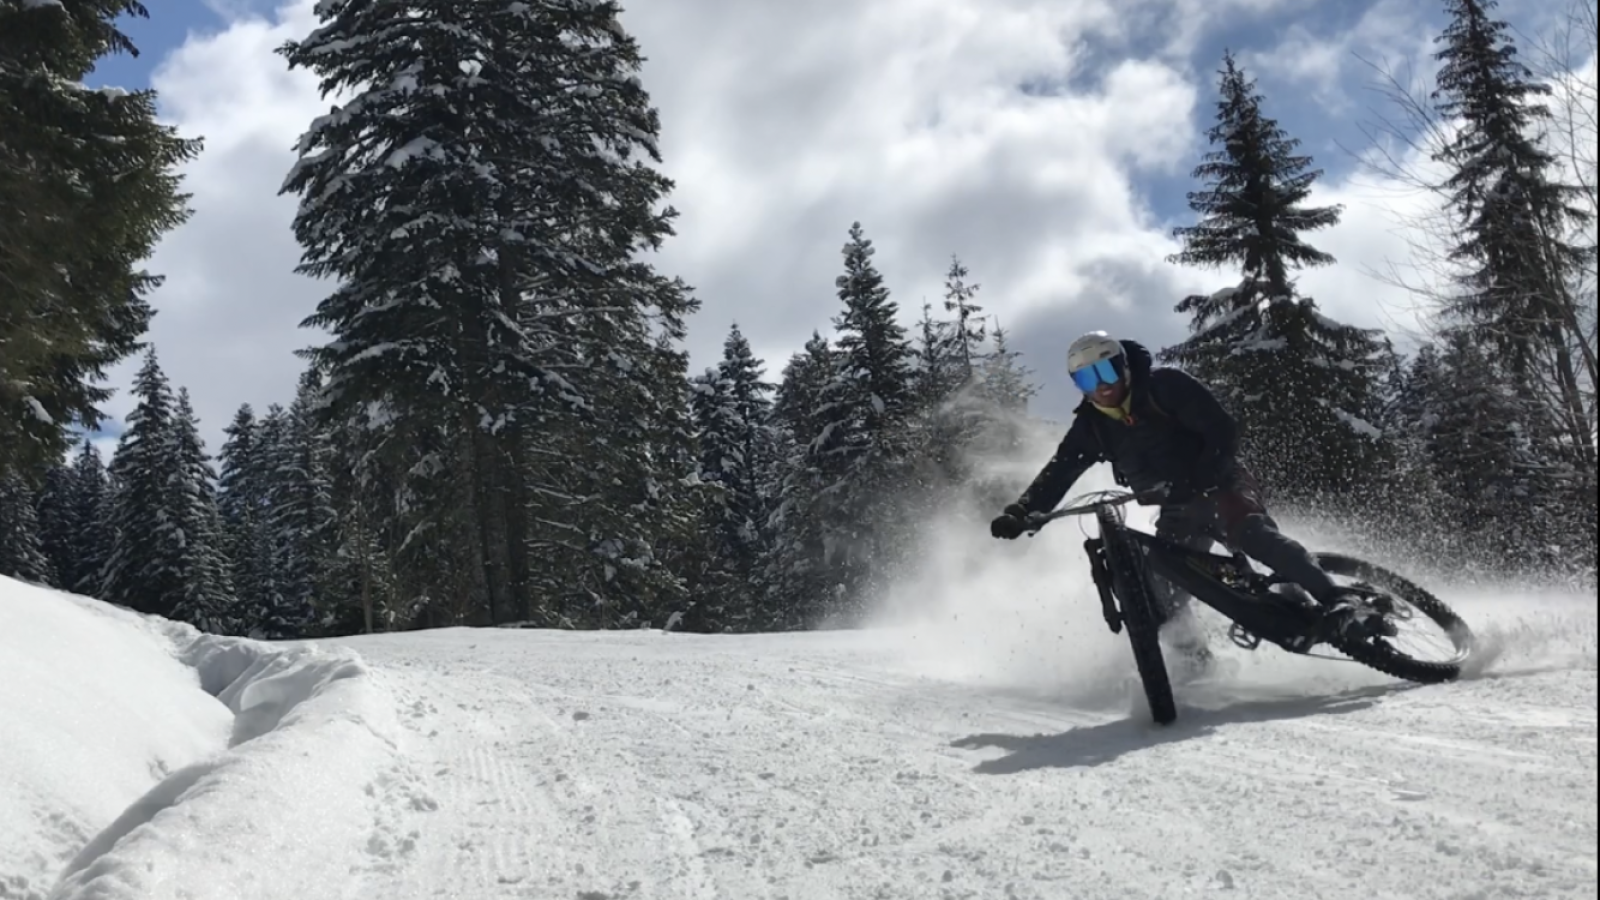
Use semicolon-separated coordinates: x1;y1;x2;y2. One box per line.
72;0;1592;452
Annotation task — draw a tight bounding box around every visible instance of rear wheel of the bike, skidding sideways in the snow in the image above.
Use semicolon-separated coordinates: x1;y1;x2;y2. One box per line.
1314;552;1474;684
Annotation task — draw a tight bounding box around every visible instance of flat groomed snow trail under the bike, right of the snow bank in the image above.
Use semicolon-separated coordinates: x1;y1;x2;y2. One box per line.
331;612;1600;900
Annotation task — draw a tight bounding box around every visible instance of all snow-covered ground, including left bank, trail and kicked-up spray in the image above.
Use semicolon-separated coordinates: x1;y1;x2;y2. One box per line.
0;509;1600;900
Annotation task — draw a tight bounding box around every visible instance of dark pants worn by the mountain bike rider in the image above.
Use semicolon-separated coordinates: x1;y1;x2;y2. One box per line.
1154;468;1338;617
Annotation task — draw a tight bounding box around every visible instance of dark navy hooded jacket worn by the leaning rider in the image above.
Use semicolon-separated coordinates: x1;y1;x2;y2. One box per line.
1018;341;1238;512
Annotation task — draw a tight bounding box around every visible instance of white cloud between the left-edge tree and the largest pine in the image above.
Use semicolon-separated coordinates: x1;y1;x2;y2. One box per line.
97;3;323;452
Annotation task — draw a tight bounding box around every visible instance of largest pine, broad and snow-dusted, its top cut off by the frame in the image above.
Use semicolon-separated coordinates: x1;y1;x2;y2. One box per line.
283;0;694;621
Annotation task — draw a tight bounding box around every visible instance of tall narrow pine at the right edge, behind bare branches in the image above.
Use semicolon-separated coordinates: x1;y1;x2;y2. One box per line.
1434;0;1597;506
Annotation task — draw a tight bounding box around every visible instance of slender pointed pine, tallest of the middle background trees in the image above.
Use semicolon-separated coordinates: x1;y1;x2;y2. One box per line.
810;223;915;615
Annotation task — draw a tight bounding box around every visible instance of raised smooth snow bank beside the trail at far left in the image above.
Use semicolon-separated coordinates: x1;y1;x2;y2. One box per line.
0;578;412;900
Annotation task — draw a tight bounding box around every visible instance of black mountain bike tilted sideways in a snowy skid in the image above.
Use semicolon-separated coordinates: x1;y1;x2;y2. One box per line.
1024;490;1472;725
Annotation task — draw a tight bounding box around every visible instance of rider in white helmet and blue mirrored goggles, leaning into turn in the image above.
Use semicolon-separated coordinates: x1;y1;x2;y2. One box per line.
989;331;1376;655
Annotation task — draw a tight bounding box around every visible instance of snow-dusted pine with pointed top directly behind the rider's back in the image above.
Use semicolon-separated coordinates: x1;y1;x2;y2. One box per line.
1160;54;1389;503
